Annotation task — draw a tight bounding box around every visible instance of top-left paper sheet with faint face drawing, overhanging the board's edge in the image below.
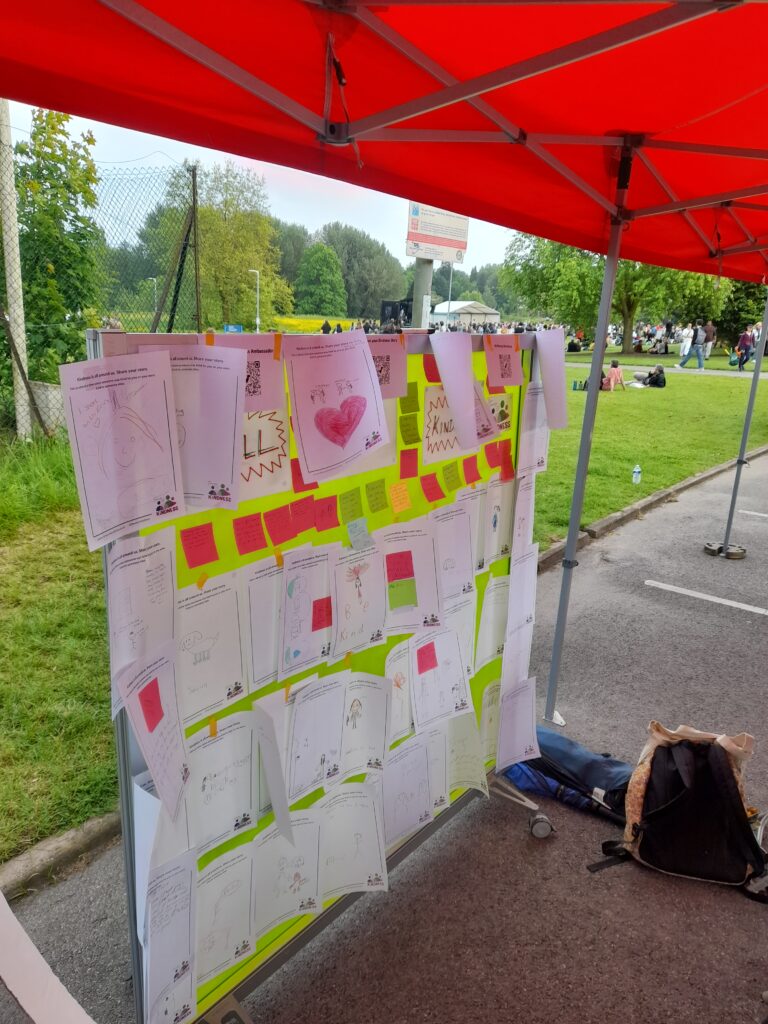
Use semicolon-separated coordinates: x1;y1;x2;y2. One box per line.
58;352;186;551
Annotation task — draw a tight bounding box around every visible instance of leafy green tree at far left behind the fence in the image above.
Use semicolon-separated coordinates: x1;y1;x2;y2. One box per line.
0;110;104;382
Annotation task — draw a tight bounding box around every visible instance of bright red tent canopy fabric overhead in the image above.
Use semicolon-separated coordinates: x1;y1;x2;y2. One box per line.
6;0;768;282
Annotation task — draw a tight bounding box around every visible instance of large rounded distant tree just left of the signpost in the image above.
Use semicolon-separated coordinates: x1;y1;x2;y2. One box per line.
321;221;406;316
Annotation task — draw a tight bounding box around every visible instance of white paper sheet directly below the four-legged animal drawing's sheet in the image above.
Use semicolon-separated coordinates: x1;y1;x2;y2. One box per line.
186;712;264;854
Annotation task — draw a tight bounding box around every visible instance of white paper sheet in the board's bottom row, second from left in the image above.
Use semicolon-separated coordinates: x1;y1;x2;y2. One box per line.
197;843;255;985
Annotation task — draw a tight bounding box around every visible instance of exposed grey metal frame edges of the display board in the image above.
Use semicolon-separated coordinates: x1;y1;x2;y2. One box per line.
86;329;535;1024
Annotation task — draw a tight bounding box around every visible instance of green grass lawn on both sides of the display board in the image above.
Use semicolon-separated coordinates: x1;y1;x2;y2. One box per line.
0;368;768;861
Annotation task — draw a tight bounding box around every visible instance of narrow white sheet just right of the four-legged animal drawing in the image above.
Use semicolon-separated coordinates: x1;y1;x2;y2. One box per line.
240;558;283;690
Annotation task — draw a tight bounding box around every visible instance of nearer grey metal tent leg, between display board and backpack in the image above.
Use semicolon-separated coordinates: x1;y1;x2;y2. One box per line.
544;220;622;725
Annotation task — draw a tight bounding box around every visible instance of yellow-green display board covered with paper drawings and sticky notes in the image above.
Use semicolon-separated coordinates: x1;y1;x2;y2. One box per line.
70;332;552;1024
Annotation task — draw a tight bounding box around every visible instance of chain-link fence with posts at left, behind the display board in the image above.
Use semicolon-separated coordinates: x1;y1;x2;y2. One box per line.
0;162;201;437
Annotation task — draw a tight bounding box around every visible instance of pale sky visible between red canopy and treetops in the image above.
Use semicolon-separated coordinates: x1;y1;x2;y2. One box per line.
10;102;513;271
